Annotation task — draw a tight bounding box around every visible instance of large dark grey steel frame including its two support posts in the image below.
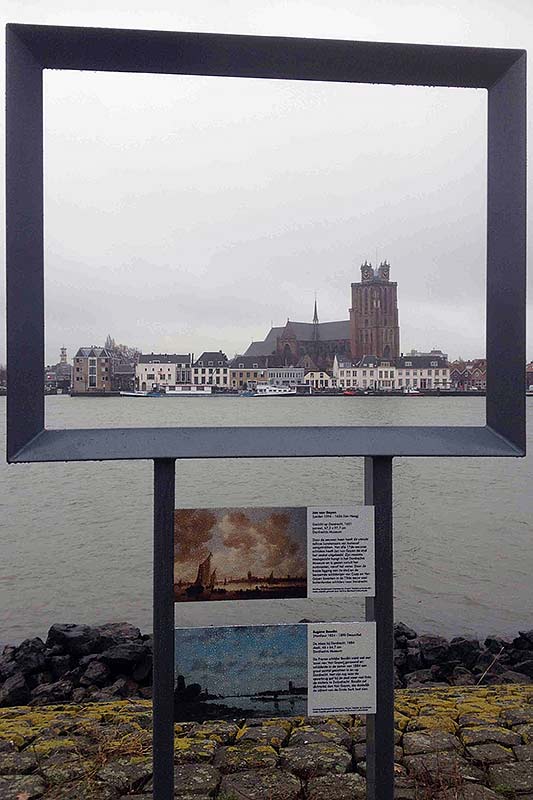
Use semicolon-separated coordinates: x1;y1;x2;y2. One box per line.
6;24;526;800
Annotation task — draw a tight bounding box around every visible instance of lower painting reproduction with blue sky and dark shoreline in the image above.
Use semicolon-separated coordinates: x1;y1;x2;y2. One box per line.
174;624;308;722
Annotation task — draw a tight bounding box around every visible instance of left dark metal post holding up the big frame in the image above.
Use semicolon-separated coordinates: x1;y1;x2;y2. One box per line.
153;458;176;800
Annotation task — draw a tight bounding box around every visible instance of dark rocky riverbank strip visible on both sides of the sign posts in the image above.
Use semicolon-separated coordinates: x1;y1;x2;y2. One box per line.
0;622;533;706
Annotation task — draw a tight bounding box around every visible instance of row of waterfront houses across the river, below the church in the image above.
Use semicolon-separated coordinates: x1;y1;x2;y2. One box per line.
45;346;533;393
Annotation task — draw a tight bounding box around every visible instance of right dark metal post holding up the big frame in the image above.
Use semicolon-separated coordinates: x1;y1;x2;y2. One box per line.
365;456;394;800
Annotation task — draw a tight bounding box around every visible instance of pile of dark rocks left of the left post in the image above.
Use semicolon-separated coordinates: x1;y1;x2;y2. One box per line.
0;622;152;706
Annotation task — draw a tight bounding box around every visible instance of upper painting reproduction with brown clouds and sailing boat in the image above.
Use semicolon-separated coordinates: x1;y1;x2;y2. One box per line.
174;507;307;602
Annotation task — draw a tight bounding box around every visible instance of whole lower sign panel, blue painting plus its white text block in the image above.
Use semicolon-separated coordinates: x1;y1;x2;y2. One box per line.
174;622;376;722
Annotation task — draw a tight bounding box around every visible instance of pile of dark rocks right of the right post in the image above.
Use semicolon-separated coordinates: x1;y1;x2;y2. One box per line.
394;622;533;689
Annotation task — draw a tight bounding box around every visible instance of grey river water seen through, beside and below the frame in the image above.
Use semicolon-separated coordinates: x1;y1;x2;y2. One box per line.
0;396;533;642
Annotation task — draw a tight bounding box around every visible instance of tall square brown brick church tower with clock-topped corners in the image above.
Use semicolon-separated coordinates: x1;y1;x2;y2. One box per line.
350;260;400;358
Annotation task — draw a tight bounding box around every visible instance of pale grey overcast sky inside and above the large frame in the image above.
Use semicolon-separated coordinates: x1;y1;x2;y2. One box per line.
0;0;533;363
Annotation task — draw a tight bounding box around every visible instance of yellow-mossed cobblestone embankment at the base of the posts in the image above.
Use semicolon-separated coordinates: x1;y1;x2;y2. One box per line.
0;685;533;800
